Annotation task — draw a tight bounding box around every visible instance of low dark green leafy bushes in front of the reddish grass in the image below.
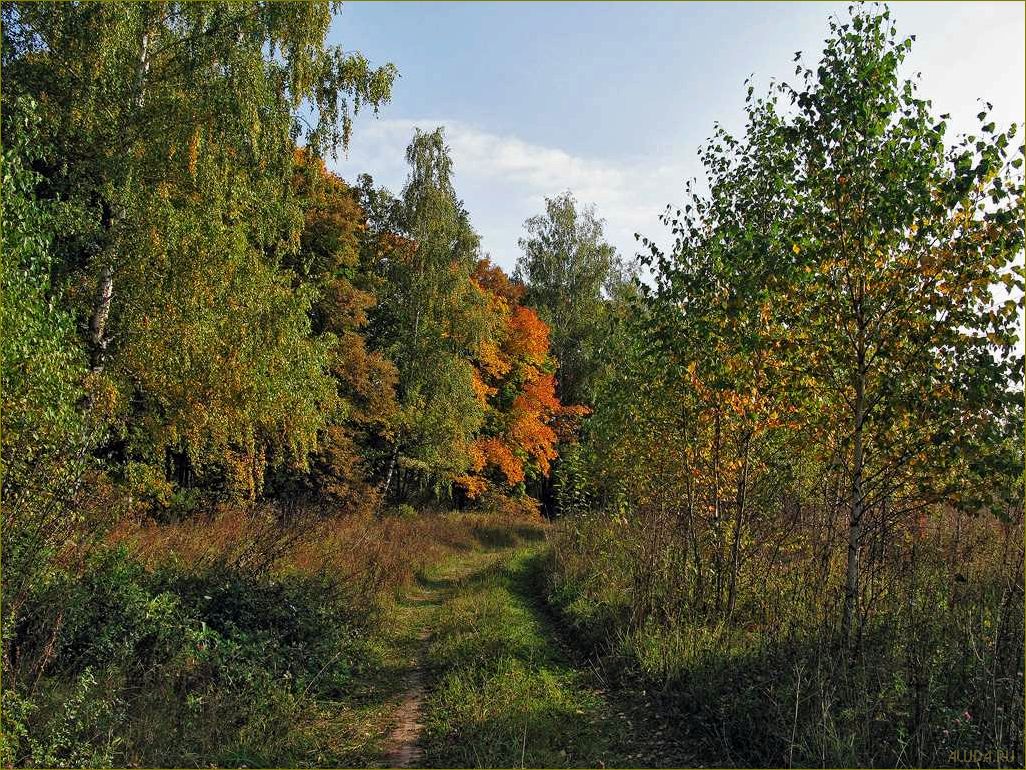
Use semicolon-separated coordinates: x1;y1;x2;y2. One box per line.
2;548;370;766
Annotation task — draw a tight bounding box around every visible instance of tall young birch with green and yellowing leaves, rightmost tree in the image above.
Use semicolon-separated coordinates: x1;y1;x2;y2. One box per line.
775;9;1024;637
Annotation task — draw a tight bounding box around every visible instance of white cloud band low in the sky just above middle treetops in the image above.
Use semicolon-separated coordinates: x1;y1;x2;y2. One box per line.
336;119;694;269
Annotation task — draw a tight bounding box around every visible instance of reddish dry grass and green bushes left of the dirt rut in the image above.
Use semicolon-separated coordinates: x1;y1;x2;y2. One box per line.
0;510;541;767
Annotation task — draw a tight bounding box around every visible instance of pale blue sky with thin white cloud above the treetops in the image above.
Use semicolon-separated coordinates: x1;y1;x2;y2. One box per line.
329;2;1026;269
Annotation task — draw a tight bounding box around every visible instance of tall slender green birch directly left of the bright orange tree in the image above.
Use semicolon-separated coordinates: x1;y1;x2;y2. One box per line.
371;128;491;501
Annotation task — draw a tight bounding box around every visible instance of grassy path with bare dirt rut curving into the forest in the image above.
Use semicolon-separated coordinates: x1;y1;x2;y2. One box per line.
376;545;699;768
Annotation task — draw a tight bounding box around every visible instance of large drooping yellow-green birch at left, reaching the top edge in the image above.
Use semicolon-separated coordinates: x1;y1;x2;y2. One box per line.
3;3;395;501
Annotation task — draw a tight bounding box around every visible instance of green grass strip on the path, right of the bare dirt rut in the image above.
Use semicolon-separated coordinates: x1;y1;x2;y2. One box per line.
423;547;616;767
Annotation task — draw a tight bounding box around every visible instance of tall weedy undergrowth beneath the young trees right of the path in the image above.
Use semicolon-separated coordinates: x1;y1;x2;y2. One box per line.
547;515;1023;767
